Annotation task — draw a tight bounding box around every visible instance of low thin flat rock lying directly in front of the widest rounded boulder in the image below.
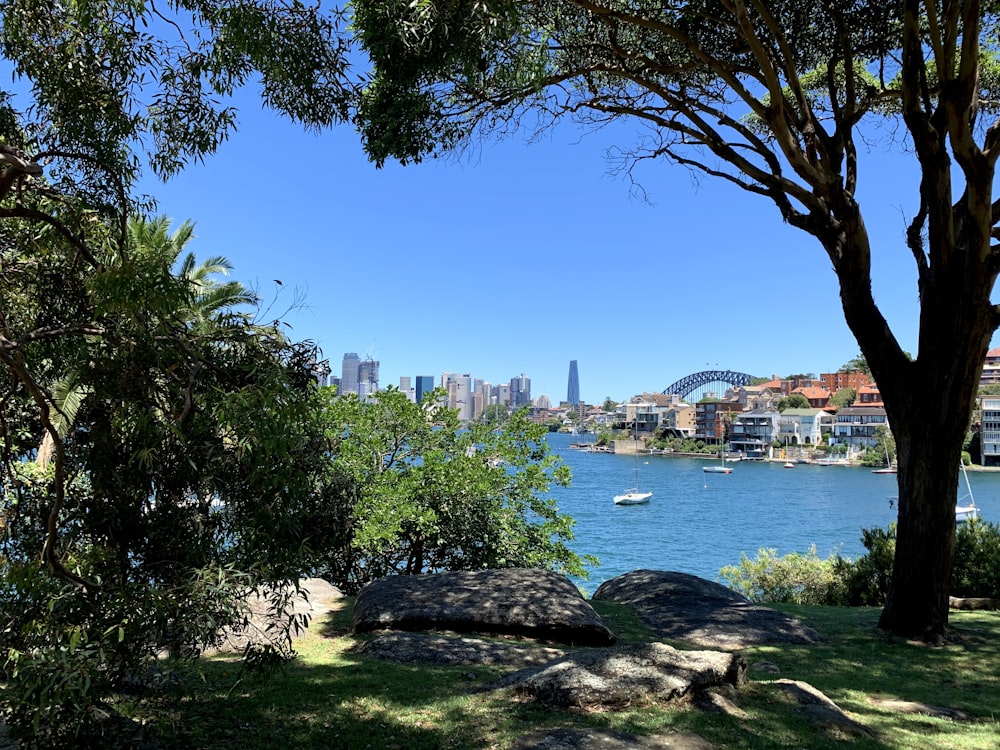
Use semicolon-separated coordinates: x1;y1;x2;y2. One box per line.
360;633;566;668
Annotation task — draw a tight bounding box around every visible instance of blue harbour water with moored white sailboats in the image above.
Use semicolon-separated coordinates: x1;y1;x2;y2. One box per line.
548;433;1000;593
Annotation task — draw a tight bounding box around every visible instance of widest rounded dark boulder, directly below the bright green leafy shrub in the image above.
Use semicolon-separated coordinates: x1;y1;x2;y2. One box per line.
354;568;615;646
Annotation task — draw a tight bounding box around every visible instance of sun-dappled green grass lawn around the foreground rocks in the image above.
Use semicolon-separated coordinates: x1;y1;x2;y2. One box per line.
123;601;1000;750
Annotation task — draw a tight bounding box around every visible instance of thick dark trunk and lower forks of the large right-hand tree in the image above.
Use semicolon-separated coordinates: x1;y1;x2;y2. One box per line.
825;181;996;642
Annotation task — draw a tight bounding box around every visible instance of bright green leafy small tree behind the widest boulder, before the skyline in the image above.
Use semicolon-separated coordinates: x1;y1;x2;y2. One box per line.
322;389;589;591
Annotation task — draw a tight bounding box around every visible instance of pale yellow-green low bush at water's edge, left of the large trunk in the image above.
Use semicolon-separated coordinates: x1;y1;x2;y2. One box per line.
719;545;844;605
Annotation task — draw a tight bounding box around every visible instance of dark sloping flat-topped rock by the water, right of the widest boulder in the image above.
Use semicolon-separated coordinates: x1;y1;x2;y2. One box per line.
594;570;823;650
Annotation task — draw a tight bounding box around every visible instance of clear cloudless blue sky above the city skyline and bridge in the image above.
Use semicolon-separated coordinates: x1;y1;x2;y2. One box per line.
145;92;944;403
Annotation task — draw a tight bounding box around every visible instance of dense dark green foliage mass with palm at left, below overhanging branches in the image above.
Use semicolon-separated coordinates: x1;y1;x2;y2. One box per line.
0;214;334;744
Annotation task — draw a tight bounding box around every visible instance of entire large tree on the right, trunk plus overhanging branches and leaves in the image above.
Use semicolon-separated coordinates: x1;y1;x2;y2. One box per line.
354;0;1000;640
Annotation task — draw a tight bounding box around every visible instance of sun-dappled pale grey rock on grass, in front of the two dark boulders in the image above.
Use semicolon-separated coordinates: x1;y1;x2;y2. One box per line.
488;643;746;709
